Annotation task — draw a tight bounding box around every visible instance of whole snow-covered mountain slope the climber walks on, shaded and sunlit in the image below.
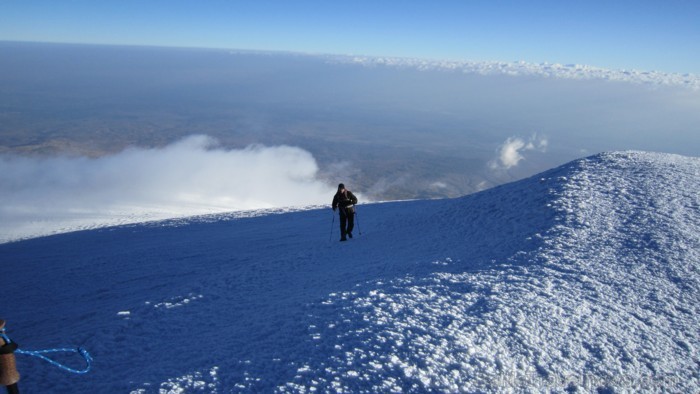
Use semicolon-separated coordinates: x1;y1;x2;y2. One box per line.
0;152;700;393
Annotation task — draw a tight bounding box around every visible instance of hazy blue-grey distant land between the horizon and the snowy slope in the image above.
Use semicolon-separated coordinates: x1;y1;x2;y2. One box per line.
0;42;700;200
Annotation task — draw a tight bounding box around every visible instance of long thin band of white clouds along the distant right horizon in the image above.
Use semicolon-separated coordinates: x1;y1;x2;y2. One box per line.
328;56;700;90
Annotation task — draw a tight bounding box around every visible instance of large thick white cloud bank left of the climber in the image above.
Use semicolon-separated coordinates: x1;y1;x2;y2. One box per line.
0;135;334;242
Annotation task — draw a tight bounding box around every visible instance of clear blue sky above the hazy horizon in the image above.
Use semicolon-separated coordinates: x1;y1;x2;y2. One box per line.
0;0;700;74
